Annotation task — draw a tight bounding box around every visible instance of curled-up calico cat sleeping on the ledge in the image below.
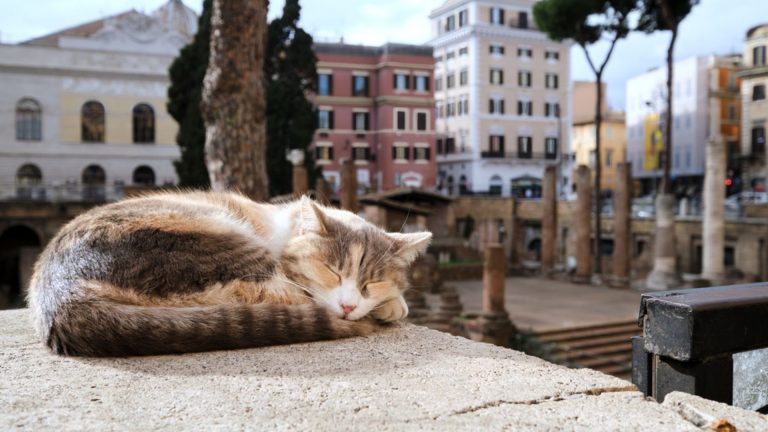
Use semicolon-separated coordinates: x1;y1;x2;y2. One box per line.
29;192;432;356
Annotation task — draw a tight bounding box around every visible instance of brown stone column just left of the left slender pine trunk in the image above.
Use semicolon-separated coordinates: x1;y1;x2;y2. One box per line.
573;165;599;283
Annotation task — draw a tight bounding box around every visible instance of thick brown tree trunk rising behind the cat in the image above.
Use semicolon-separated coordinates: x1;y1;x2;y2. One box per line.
203;0;269;200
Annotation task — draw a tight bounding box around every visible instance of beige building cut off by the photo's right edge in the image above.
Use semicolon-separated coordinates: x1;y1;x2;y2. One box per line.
739;24;768;191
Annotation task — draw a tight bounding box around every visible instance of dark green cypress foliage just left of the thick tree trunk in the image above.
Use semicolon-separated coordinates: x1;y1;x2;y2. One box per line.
167;0;212;188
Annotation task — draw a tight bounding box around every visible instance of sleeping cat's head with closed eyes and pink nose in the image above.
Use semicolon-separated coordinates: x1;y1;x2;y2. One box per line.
283;199;432;320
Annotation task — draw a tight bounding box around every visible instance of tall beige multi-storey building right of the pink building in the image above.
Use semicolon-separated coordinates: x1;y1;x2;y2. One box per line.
430;0;571;198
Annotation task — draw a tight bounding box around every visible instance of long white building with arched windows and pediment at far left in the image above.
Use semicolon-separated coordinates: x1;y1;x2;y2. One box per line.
0;0;197;200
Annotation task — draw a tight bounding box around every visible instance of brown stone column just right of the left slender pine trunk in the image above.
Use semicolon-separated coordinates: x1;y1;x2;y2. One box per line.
612;162;632;288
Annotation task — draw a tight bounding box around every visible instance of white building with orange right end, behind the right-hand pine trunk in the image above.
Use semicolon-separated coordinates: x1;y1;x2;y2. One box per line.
625;56;740;194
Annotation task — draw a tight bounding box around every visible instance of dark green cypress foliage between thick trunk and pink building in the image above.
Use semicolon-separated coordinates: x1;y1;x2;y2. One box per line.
264;0;317;196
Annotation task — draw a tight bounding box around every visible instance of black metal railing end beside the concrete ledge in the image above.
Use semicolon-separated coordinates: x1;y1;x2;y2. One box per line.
632;283;768;413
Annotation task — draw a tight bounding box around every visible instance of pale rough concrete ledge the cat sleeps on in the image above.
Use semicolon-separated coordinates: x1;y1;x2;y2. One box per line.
0;310;760;431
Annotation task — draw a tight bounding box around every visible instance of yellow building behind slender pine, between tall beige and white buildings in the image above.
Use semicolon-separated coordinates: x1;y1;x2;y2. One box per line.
571;112;626;193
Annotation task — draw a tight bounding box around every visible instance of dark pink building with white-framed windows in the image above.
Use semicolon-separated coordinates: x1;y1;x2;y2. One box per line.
312;43;437;191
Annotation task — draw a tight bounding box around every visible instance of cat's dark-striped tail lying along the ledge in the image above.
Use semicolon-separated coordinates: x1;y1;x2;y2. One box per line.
45;300;378;357
